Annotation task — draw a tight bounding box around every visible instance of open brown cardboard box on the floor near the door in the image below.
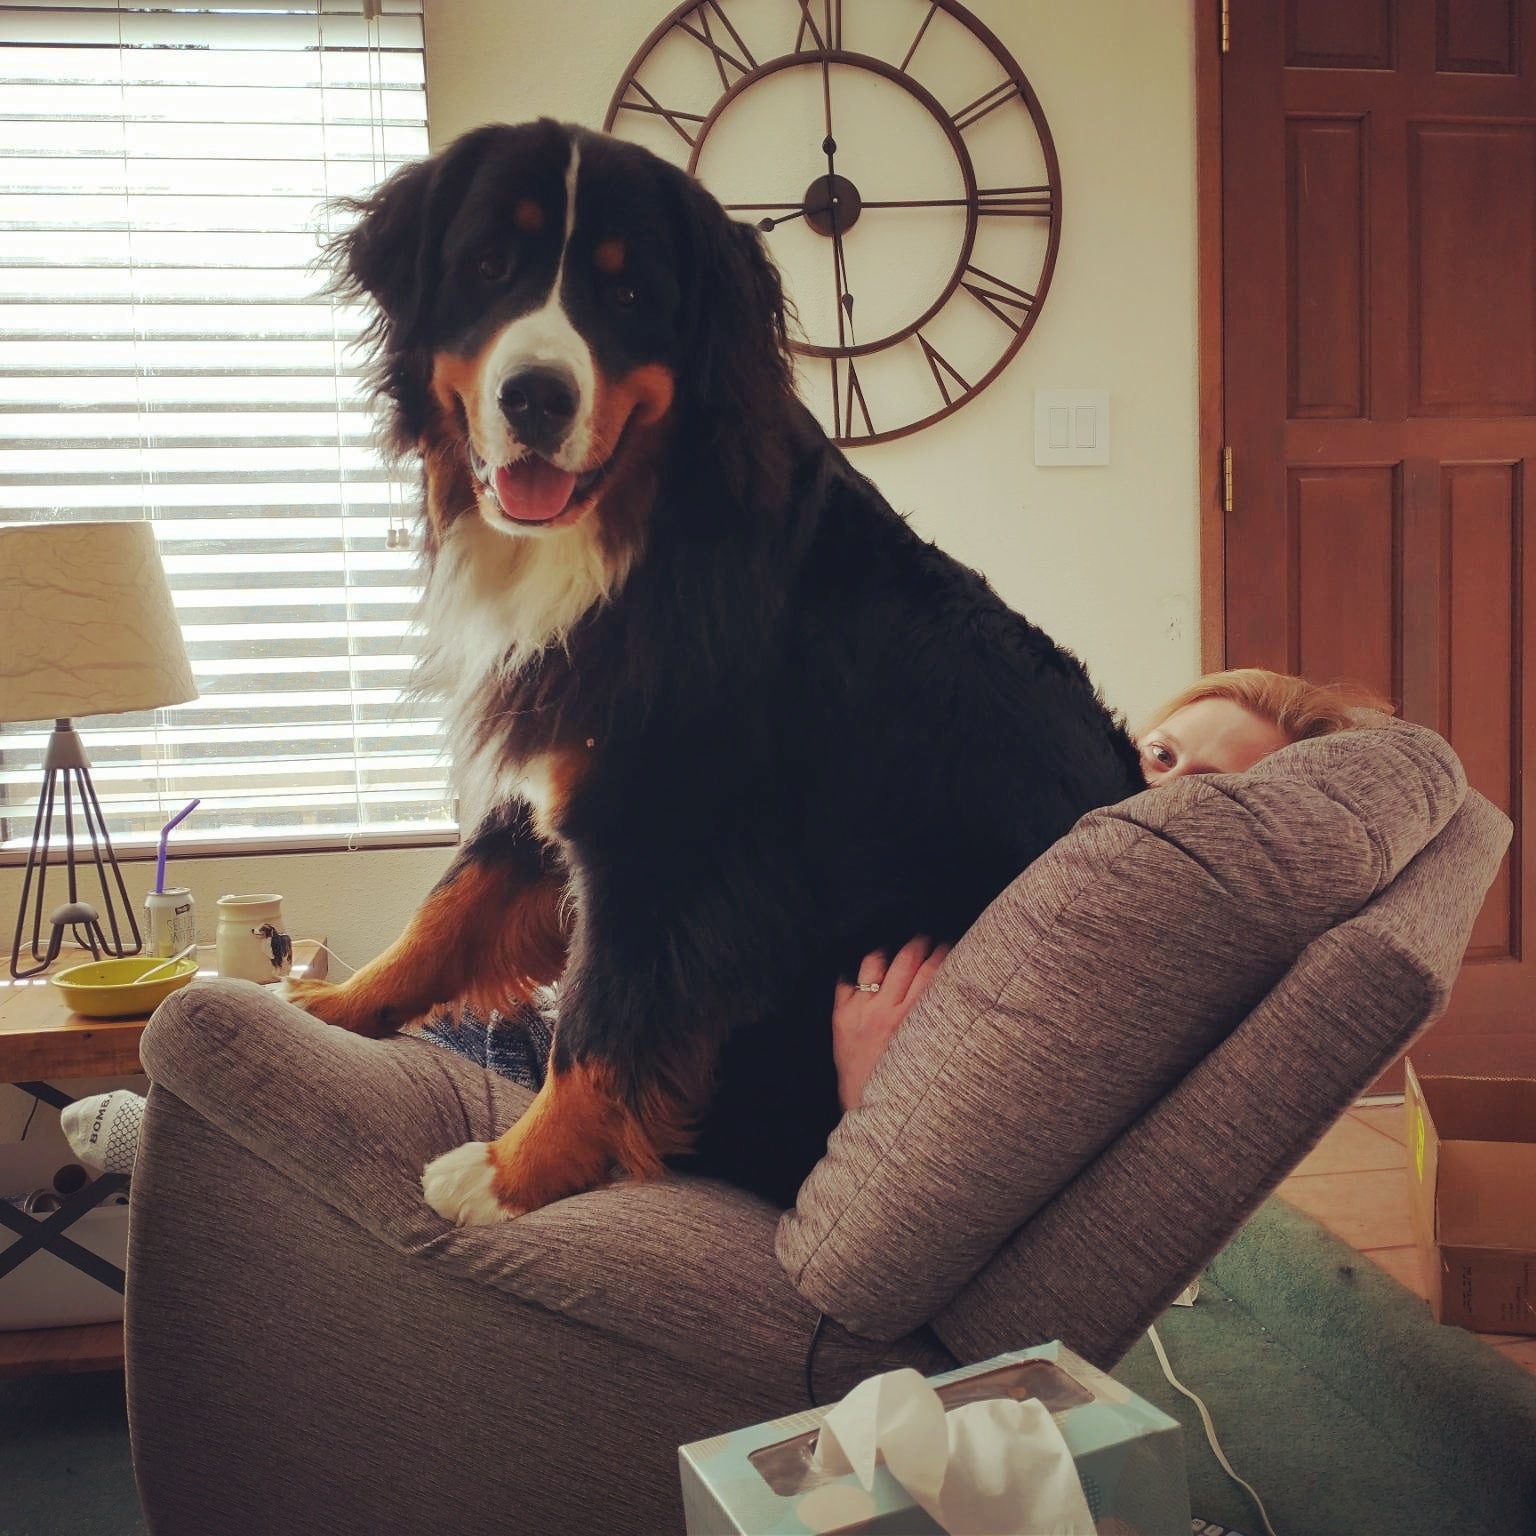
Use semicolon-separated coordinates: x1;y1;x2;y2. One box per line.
1404;1060;1536;1333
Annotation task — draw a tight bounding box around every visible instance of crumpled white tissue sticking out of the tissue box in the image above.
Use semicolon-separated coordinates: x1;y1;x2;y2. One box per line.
816;1370;1094;1536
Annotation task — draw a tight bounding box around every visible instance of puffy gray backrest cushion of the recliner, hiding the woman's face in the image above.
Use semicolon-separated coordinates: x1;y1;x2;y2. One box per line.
777;716;1465;1338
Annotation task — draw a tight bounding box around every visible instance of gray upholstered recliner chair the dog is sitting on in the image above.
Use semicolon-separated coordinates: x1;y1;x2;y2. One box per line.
127;722;1508;1536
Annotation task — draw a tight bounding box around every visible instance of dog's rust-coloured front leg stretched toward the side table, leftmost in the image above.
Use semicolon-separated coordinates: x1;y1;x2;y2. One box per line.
283;805;565;1035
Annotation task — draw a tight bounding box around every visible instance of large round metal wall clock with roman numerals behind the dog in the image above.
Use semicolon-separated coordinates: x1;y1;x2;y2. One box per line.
604;0;1061;447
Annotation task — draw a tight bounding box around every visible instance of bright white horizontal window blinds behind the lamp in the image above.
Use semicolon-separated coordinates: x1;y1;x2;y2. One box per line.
0;0;452;848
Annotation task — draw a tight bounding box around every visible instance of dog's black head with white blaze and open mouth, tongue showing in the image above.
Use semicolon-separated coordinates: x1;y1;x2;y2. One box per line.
330;120;791;538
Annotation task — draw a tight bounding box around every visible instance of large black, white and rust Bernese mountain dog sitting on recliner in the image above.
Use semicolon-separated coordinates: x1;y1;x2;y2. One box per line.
289;120;1141;1224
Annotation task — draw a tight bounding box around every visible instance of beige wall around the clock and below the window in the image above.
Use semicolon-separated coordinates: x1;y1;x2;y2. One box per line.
0;0;1198;1135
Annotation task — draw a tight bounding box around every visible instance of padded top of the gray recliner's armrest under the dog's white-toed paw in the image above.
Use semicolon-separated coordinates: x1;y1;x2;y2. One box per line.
141;982;948;1407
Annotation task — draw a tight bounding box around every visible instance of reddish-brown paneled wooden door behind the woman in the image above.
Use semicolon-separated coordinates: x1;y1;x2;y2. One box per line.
1221;0;1536;1086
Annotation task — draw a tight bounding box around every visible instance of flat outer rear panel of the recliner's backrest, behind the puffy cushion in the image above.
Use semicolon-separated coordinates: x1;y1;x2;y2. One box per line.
932;791;1510;1370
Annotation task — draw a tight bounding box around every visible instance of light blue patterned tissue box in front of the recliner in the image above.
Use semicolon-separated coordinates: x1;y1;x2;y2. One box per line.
677;1344;1190;1536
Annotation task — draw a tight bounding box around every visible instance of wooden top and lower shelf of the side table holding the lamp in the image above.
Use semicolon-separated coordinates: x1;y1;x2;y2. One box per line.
0;942;327;1376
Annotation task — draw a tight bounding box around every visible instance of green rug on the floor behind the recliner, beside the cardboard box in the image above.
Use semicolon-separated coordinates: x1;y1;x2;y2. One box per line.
1115;1200;1536;1536
